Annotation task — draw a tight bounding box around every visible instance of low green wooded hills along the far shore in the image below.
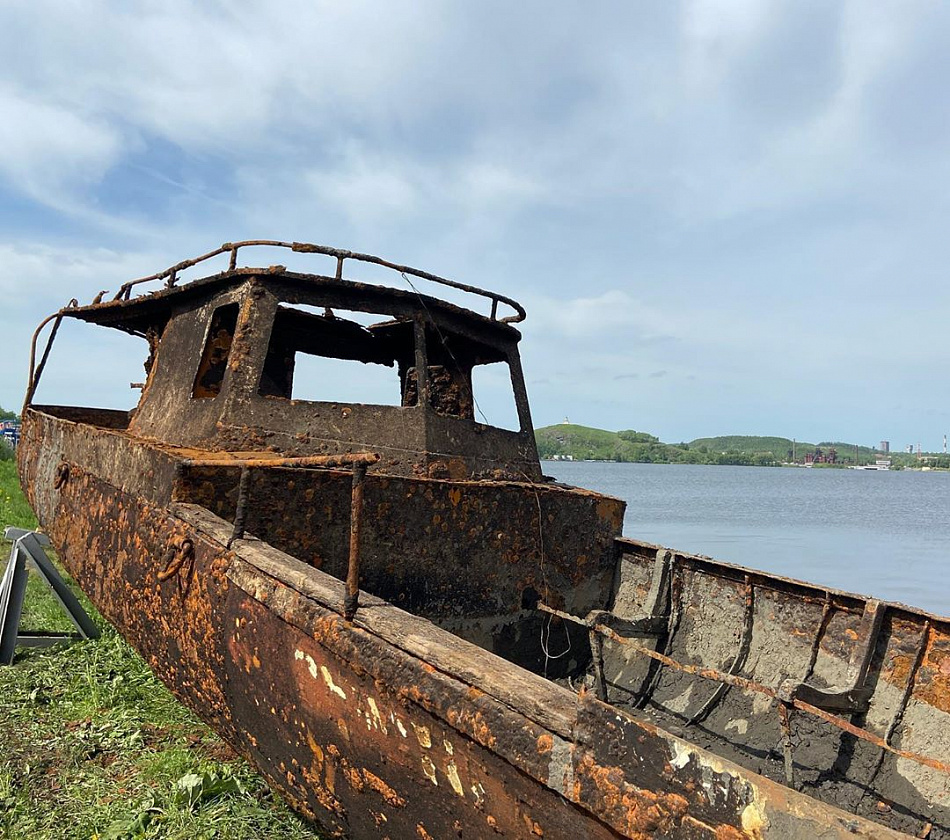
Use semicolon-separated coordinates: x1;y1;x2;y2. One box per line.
534;423;896;466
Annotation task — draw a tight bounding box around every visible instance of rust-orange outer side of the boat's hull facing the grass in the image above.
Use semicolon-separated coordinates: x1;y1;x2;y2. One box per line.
19;409;939;840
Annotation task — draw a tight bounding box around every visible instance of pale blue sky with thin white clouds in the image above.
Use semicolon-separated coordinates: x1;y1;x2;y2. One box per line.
0;0;950;450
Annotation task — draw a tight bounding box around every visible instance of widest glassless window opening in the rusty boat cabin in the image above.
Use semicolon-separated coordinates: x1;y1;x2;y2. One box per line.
258;305;415;406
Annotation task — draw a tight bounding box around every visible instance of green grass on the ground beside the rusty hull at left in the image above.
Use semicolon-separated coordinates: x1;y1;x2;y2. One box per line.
0;461;319;840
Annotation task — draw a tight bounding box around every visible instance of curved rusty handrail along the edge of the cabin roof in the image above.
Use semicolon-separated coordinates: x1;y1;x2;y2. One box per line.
113;239;526;324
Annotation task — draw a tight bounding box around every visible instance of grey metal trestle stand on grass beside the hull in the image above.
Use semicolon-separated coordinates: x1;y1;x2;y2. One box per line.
0;528;99;665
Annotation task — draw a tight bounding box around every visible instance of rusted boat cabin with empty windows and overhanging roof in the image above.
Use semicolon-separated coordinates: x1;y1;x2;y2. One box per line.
59;256;541;481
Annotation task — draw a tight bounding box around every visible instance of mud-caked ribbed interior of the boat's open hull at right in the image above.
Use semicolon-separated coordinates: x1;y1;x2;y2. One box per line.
600;540;950;838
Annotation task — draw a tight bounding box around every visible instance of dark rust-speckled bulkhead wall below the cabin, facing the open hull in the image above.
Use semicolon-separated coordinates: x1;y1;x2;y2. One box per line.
177;467;623;674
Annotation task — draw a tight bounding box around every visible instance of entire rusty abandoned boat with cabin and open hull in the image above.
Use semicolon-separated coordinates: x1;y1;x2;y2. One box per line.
18;242;950;840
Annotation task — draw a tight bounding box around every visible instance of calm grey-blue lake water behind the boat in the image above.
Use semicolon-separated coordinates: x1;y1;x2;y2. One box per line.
543;461;950;615
